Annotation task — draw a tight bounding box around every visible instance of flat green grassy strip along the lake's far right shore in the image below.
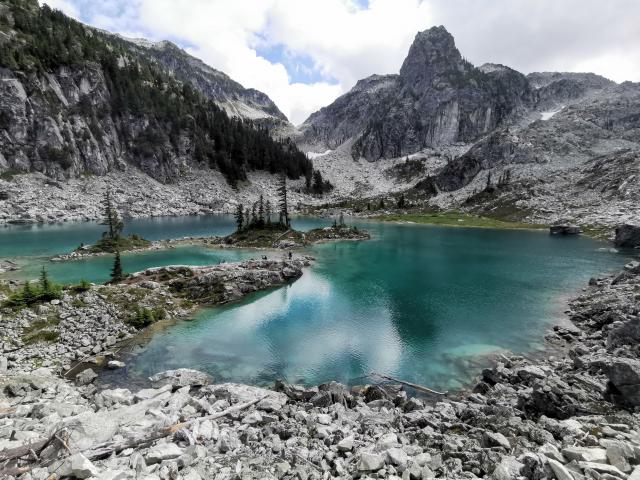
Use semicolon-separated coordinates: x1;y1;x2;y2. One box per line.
373;212;549;229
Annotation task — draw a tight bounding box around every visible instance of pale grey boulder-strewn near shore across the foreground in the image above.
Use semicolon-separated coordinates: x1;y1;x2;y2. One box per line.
0;256;640;480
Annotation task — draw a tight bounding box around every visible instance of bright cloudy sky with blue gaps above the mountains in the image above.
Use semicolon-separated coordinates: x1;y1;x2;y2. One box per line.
44;0;640;124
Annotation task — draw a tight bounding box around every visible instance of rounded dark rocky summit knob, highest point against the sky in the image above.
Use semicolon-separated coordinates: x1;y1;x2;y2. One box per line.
400;26;470;88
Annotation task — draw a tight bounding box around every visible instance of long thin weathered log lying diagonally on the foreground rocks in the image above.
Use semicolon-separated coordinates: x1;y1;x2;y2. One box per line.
80;396;267;460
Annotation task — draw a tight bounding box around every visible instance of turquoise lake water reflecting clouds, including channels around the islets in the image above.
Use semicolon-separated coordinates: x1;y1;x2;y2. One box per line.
0;216;628;389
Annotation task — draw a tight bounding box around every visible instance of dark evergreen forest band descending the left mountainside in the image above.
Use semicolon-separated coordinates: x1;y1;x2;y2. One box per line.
0;0;333;190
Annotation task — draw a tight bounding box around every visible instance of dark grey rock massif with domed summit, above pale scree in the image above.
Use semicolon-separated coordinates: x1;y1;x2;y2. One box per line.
301;27;534;160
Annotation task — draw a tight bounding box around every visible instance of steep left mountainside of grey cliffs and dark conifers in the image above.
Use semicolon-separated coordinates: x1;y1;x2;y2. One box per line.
0;0;313;185
